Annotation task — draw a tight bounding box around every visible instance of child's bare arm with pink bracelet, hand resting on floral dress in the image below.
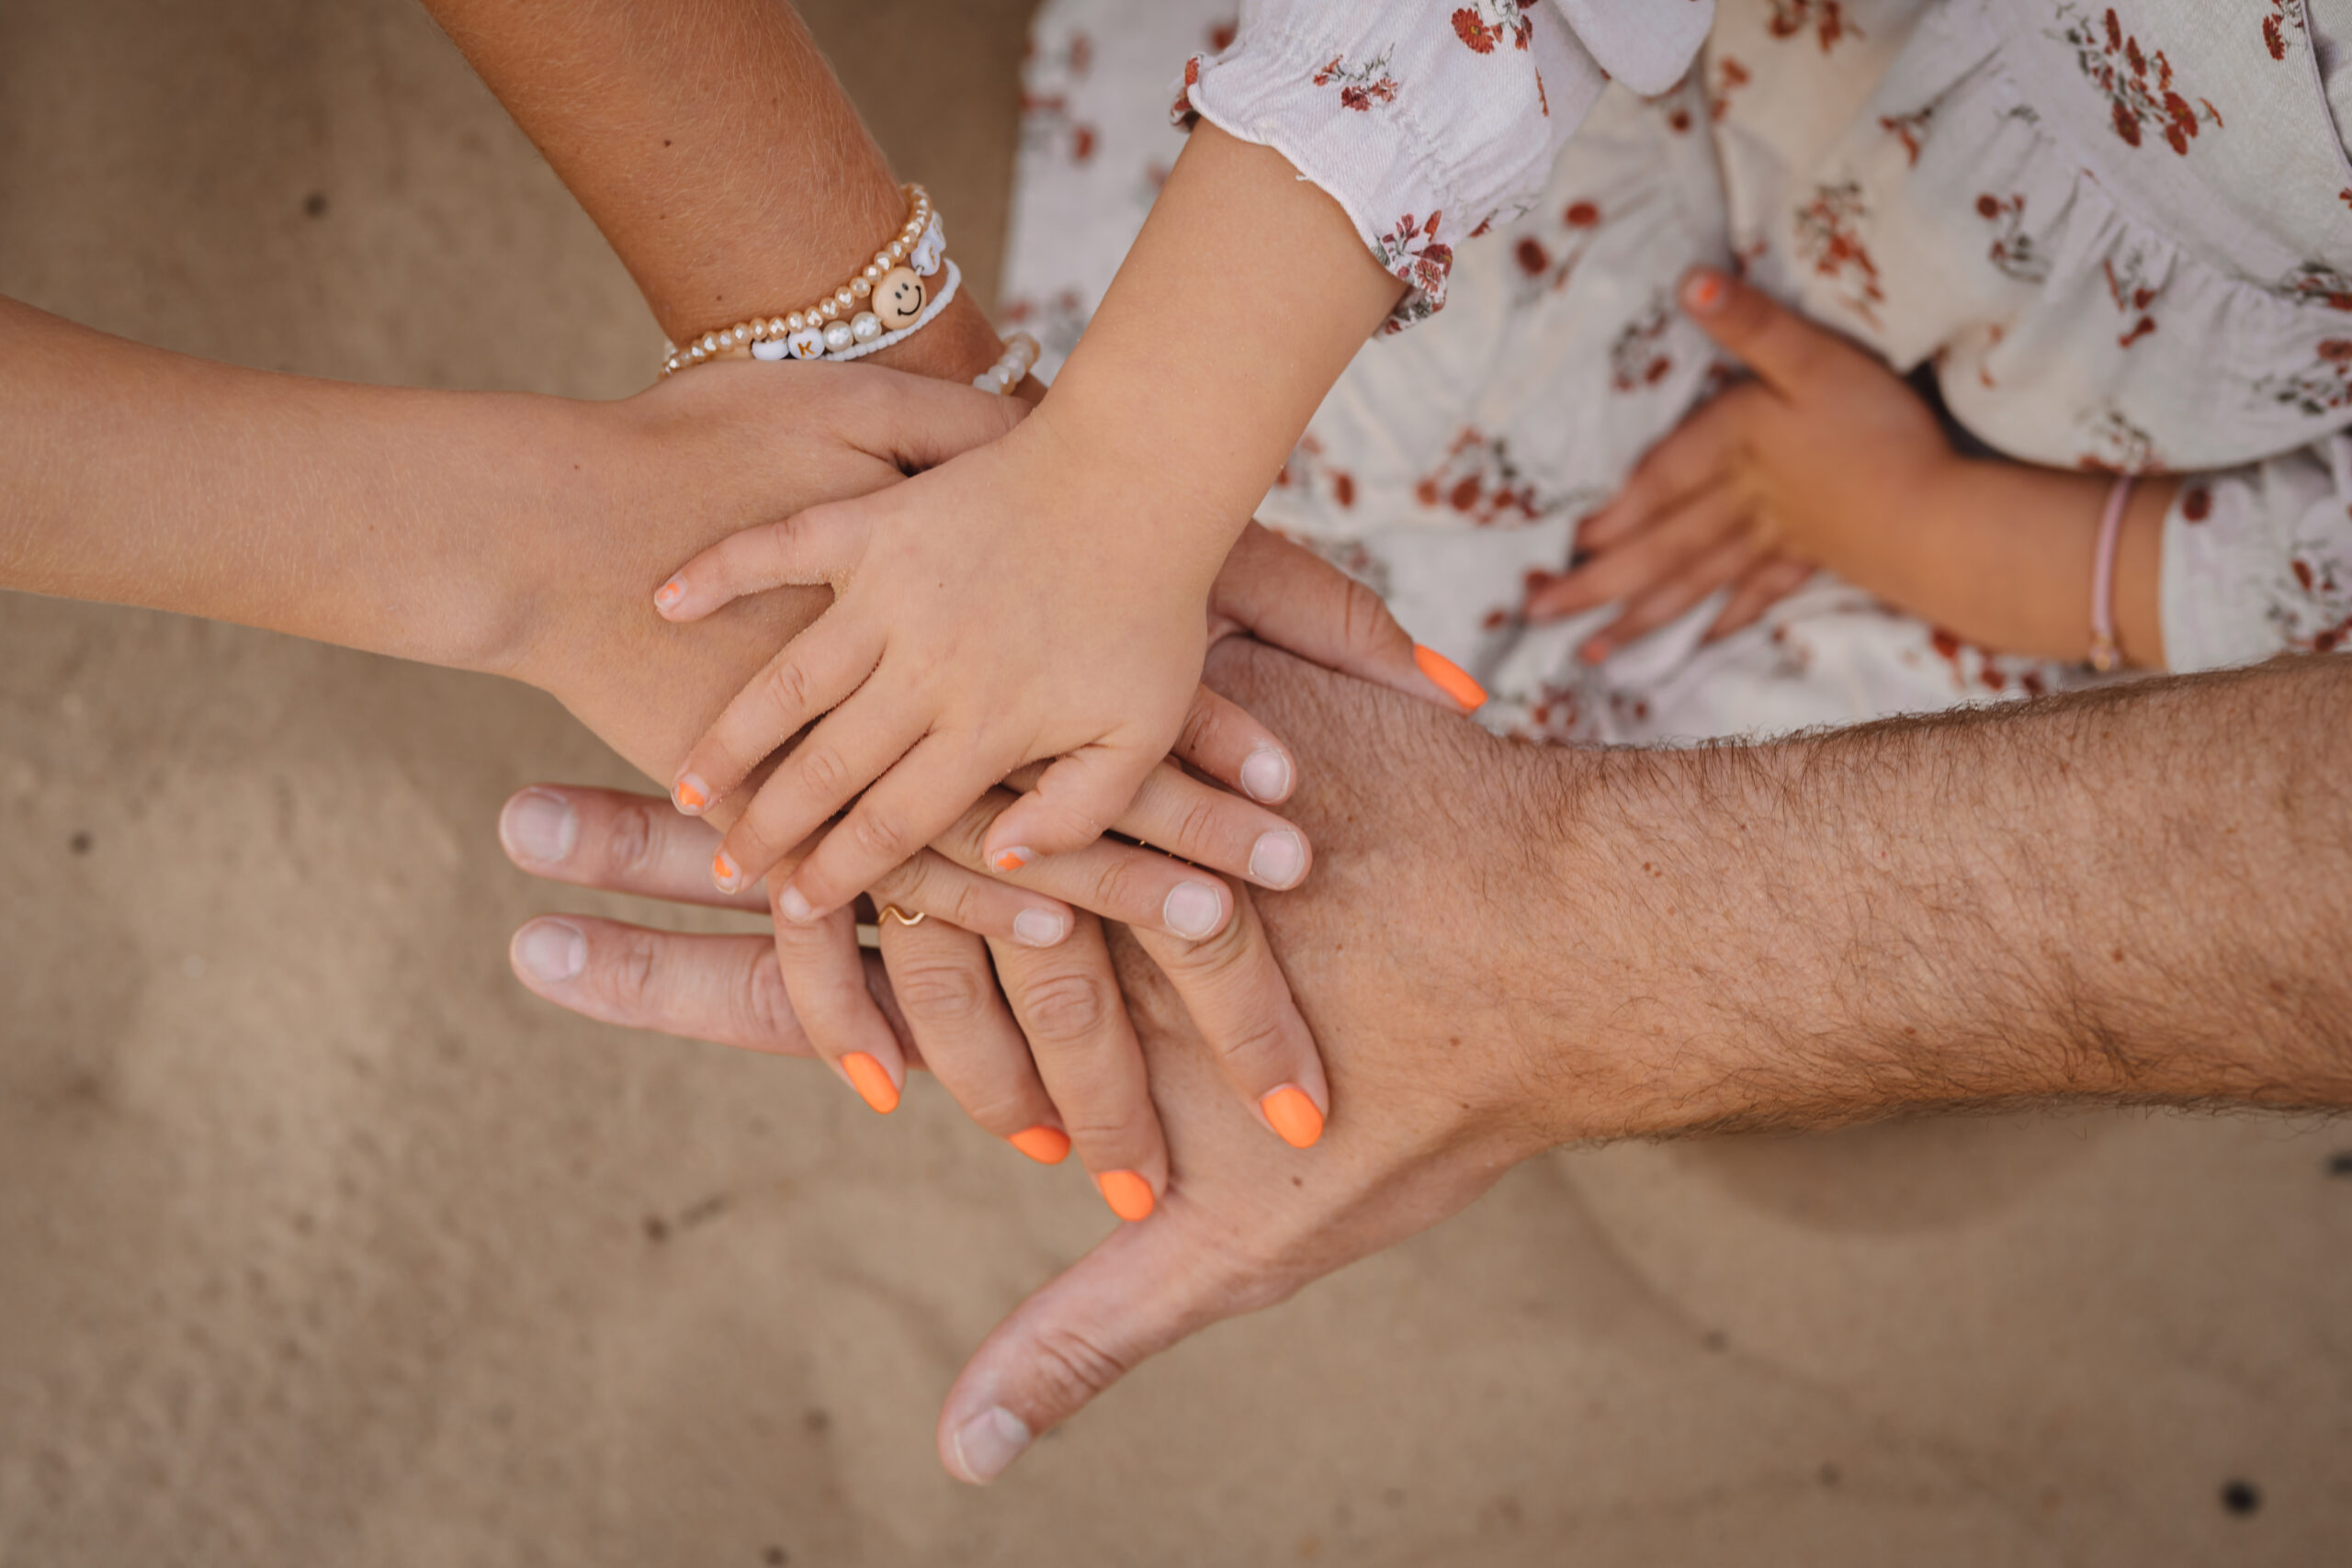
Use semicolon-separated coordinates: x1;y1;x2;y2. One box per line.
1529;273;2178;668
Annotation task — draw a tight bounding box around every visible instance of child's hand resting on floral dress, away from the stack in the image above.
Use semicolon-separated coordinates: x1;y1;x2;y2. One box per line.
1526;270;1959;663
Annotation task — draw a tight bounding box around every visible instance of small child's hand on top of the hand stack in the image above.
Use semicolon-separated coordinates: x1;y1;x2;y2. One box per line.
656;416;1223;921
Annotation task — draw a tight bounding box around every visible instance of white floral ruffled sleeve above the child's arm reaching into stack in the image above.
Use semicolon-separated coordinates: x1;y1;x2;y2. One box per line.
1173;0;1714;332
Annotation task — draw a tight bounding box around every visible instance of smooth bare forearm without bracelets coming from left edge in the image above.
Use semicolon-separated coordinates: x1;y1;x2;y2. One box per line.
0;301;555;668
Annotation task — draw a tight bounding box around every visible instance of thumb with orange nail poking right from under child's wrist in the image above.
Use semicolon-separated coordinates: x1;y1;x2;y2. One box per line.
1209;522;1477;712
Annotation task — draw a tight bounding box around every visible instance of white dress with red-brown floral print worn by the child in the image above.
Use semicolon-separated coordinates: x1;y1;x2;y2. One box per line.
1007;0;2352;740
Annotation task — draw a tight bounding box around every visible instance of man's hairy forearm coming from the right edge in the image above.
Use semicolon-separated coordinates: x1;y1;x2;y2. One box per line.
1547;659;2352;1135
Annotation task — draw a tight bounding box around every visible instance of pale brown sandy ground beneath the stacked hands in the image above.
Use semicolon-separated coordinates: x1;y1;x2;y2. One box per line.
0;0;2352;1568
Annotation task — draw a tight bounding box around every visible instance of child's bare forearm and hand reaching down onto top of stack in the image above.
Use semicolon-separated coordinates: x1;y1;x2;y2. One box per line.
659;127;1402;919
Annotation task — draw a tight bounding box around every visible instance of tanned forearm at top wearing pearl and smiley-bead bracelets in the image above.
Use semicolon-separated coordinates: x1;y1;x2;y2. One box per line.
425;0;997;378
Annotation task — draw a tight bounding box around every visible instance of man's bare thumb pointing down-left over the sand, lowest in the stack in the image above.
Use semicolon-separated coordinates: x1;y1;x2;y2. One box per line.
938;1206;1275;1485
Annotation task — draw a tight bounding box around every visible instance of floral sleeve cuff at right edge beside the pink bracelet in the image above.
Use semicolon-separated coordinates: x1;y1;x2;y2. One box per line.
2162;434;2352;672
